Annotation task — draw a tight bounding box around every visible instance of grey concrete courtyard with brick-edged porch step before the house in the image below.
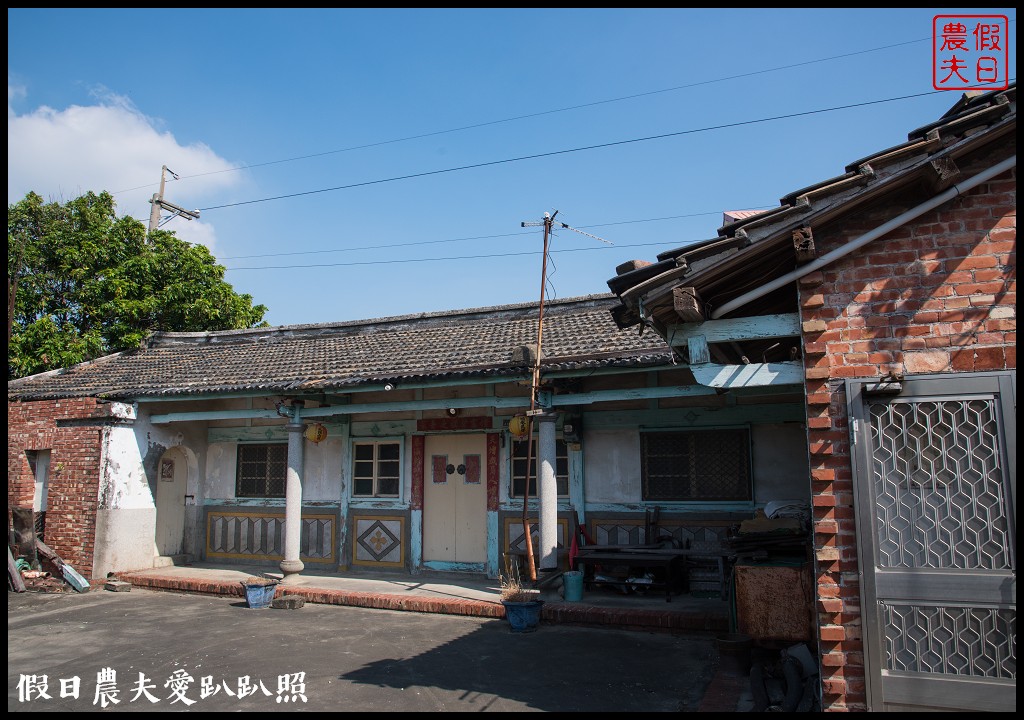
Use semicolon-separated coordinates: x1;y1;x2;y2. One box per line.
7;565;751;712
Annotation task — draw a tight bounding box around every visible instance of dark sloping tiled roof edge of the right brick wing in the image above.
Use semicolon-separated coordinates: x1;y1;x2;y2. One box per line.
607;83;1017;334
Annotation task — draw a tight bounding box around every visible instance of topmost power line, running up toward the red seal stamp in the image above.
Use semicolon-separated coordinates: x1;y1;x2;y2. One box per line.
114;38;931;195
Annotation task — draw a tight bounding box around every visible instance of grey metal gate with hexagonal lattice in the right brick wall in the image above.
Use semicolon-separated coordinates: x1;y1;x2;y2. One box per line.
847;373;1017;711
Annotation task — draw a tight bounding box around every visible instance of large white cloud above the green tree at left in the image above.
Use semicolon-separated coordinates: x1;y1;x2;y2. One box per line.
7;83;242;256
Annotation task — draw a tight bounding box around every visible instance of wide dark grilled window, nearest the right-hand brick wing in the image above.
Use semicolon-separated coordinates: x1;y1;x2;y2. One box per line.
640;429;752;501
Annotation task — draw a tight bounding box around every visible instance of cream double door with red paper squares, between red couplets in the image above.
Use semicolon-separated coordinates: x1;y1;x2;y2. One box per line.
423;434;487;563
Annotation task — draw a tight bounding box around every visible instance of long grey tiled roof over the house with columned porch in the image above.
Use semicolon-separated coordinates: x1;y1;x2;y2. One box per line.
7;295;671;399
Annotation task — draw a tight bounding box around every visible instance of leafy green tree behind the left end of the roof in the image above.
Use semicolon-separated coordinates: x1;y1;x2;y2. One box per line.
7;193;267;379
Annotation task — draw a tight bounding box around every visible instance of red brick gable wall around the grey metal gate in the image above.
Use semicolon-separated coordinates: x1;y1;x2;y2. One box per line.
800;154;1017;710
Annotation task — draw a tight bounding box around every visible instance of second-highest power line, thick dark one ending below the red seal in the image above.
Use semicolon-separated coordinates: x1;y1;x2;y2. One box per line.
200;90;945;212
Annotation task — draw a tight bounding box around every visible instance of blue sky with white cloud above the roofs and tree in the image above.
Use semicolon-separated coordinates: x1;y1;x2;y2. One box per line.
7;8;1017;325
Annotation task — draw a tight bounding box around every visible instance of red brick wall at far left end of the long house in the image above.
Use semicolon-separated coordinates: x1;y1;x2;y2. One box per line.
7;397;110;578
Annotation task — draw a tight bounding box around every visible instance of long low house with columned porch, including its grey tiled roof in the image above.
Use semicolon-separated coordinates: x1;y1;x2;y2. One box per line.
8;295;809;590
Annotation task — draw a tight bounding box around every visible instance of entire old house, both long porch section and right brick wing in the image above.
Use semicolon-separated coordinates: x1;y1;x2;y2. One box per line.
8;84;1016;711
